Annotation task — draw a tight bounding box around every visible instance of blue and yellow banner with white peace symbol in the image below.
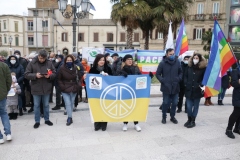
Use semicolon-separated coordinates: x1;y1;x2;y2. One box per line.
85;74;151;122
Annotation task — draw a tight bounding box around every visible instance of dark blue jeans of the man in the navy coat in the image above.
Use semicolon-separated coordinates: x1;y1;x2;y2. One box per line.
162;93;178;118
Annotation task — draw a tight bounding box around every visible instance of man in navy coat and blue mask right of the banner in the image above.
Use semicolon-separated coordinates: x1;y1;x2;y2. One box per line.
156;48;182;124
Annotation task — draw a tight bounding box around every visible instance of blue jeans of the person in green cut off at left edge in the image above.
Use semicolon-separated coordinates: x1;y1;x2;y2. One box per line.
0;98;11;139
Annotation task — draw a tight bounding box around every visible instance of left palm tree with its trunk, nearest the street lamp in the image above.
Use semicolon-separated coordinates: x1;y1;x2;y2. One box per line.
111;0;150;49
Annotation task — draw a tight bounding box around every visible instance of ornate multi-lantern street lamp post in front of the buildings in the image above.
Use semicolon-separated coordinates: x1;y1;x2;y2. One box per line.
58;0;91;52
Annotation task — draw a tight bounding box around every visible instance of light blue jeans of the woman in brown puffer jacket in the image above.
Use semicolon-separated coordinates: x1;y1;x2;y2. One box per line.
62;92;77;118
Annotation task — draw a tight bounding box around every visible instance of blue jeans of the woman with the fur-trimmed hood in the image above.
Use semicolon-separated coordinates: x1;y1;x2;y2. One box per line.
186;98;201;118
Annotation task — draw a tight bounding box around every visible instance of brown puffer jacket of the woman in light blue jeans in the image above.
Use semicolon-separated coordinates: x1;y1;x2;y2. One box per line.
58;64;82;93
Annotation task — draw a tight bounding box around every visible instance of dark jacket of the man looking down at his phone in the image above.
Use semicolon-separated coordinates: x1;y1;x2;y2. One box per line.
25;57;56;95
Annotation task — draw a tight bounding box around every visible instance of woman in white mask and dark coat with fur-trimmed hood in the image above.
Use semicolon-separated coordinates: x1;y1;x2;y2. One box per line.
184;53;207;128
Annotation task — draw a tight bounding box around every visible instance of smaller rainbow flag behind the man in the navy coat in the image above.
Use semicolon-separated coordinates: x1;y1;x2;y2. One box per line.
175;20;188;56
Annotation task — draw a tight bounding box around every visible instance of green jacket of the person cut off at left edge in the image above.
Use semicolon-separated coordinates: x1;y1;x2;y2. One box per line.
0;62;12;101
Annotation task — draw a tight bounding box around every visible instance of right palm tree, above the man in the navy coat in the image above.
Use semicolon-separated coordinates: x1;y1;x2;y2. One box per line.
153;0;193;48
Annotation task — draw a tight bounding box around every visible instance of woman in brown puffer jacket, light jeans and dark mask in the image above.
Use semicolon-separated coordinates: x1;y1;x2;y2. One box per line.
57;55;82;126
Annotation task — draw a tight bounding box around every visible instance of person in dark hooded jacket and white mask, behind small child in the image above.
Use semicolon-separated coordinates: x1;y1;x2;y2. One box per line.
7;55;24;116
